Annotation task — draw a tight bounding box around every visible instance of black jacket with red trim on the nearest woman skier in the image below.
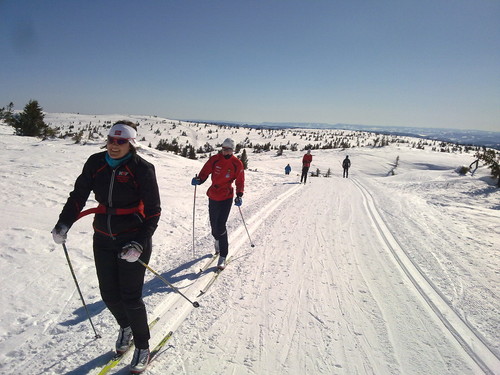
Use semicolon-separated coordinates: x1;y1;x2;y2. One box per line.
59;151;161;246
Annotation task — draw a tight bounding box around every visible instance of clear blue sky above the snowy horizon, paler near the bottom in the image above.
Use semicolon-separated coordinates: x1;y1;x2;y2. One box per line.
0;0;500;131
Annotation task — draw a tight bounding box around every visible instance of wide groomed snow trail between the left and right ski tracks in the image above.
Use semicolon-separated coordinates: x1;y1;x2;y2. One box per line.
155;178;483;375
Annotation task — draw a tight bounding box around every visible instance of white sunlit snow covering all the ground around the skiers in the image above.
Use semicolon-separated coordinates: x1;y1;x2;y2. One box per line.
0;114;500;375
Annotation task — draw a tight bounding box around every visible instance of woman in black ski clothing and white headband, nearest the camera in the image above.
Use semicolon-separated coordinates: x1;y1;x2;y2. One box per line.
52;121;161;373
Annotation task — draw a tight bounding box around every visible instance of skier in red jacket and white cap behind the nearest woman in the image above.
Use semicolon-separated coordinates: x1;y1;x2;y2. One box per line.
191;138;245;270
